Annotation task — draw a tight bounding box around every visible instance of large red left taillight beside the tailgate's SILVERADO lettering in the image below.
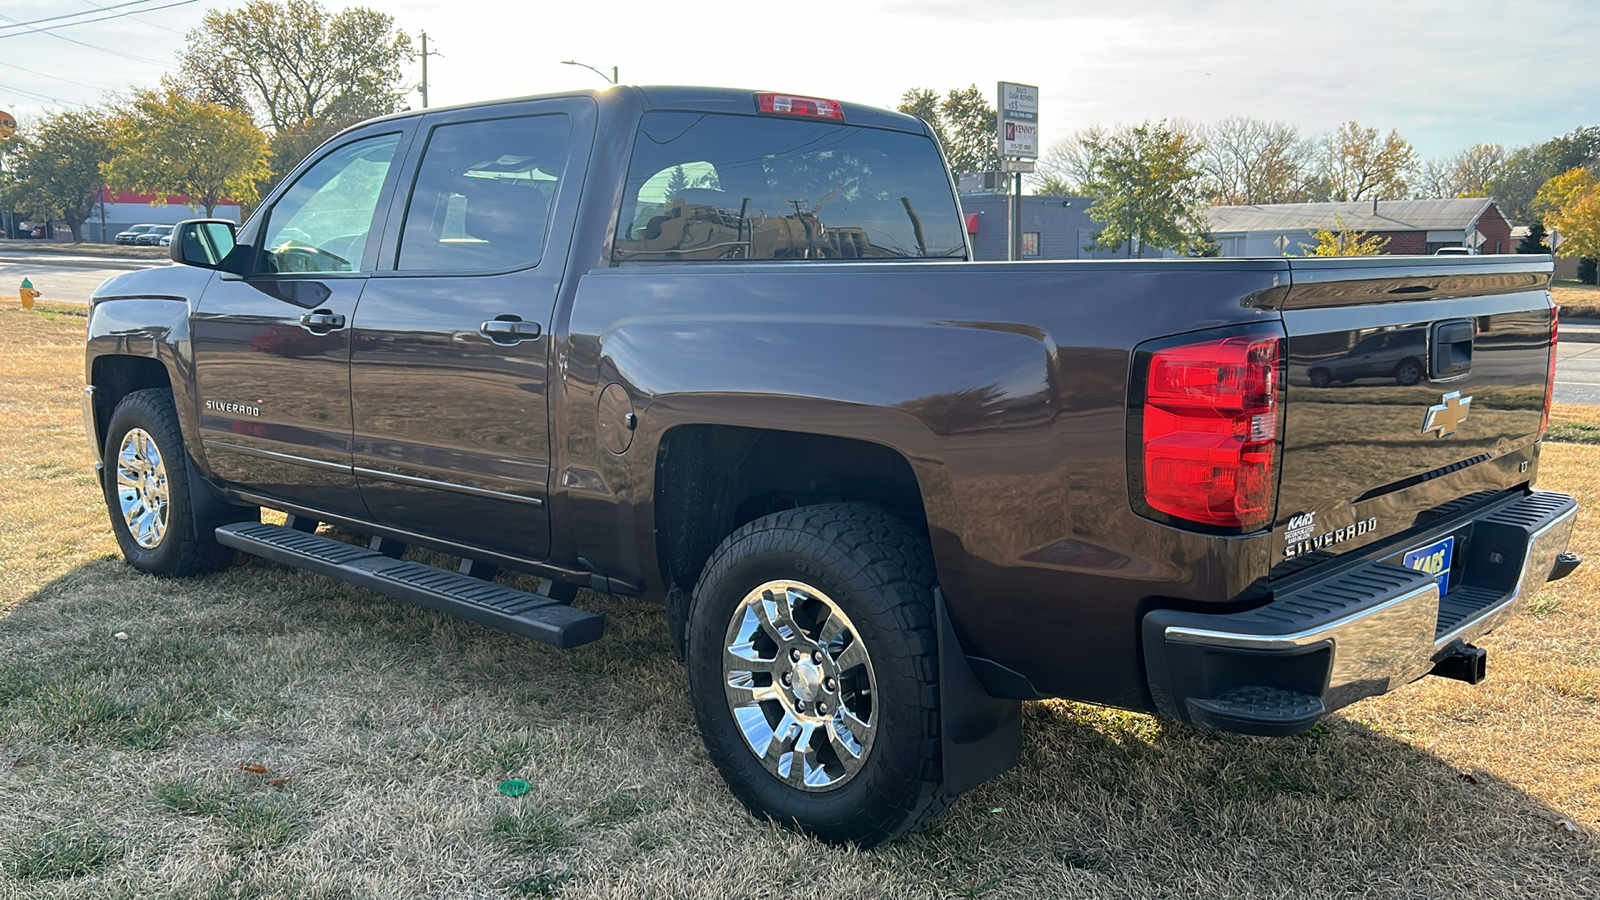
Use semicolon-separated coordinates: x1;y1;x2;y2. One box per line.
1142;335;1282;532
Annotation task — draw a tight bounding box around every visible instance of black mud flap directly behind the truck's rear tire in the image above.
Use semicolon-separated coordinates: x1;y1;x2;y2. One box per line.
933;588;1022;798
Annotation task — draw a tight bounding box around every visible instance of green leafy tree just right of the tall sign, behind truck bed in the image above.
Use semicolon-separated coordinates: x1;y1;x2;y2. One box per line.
1080;120;1206;256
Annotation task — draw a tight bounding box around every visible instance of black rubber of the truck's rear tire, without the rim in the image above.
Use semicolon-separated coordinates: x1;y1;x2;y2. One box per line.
686;503;949;847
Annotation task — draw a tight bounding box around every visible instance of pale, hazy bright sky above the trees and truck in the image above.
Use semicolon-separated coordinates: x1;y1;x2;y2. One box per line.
0;0;1600;159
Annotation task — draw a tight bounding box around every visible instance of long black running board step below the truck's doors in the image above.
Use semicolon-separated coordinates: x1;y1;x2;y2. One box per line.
216;522;605;650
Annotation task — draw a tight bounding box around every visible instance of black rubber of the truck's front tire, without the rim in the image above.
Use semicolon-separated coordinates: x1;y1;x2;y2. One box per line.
101;388;234;578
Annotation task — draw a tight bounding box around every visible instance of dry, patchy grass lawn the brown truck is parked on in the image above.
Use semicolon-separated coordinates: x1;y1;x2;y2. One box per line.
0;303;1600;900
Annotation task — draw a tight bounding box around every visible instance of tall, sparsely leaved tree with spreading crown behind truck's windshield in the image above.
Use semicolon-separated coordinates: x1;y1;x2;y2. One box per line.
166;0;416;181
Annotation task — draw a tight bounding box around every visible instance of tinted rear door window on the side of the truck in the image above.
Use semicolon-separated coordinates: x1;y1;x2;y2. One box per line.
395;115;571;271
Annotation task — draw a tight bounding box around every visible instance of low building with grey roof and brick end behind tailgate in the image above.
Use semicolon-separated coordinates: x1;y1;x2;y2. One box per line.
1206;197;1517;256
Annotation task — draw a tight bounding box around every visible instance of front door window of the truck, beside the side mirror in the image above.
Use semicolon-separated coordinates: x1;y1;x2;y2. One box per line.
258;135;400;274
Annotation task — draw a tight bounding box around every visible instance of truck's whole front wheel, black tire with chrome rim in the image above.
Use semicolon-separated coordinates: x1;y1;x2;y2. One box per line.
101;389;234;577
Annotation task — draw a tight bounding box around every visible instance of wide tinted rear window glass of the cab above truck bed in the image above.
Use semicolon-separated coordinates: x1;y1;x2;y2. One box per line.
614;112;966;261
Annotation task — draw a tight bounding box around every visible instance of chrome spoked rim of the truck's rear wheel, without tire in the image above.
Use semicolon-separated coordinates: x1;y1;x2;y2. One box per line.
722;581;878;791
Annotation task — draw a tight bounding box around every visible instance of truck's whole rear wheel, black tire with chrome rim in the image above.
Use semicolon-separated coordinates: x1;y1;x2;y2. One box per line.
688;504;947;847
